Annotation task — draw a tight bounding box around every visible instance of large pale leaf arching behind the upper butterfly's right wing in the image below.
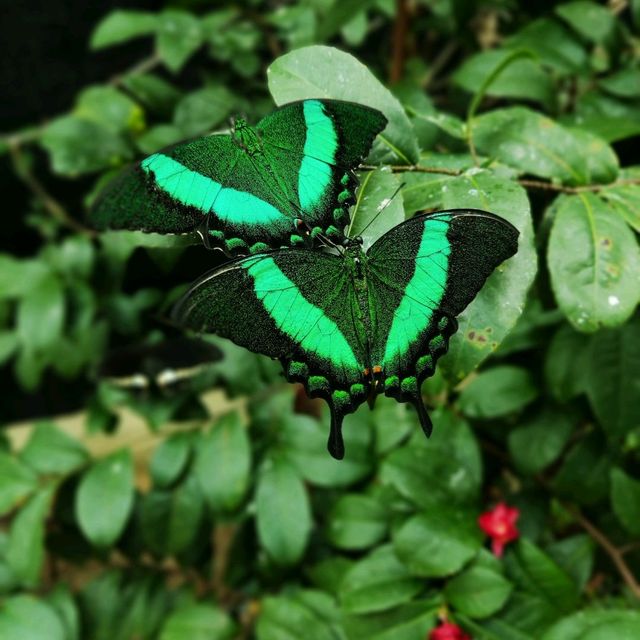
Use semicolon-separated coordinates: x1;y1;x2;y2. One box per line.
267;45;418;164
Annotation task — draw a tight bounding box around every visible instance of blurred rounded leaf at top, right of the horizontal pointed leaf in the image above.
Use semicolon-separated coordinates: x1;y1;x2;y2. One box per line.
156;9;203;73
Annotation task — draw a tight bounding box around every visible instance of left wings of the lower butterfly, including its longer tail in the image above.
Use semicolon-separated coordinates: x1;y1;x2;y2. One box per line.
174;249;366;458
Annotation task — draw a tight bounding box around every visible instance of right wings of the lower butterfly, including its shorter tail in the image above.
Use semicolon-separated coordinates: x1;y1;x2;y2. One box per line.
367;210;518;435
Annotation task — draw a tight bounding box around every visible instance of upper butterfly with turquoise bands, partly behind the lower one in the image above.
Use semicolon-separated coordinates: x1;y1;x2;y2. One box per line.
89;100;387;256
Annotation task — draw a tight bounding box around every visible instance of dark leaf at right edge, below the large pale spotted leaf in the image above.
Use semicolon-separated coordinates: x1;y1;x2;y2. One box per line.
586;320;640;438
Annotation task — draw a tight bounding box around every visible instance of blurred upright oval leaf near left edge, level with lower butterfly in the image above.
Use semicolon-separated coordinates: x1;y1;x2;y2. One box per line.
16;273;65;351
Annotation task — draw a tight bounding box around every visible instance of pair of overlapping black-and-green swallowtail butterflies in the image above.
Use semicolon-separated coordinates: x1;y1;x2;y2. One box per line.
92;100;518;458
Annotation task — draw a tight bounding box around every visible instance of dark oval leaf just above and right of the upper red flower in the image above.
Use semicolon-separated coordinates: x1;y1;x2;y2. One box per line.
509;406;574;475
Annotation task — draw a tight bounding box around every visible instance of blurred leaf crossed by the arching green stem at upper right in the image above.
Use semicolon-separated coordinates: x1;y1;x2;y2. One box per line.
452;49;555;106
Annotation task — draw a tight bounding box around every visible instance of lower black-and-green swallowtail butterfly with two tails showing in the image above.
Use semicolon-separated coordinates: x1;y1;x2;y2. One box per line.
174;210;518;459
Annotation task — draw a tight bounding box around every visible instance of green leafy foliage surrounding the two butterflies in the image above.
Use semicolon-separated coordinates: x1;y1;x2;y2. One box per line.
0;0;640;640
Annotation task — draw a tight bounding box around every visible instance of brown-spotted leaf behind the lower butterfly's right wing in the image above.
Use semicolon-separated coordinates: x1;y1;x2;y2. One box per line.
440;170;537;382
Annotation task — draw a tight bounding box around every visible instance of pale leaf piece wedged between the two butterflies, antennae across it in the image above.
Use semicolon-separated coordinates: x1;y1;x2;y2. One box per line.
347;167;404;251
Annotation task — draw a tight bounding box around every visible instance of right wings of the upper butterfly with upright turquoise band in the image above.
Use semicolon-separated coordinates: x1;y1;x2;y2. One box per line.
256;100;387;236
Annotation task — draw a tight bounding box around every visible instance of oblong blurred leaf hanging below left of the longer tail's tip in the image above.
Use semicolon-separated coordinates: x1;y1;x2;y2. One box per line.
256;457;311;565
